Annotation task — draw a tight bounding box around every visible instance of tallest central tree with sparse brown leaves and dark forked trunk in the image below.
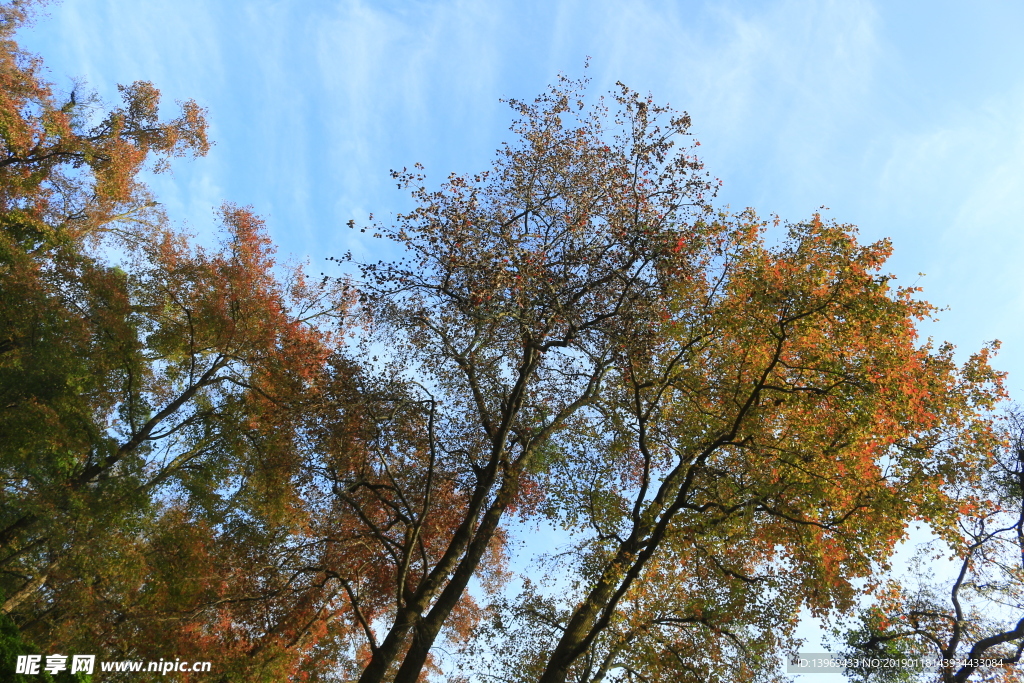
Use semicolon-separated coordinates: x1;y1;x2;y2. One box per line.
346;80;719;683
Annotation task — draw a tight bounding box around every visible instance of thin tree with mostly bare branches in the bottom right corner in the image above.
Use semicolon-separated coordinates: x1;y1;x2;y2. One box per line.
844;411;1024;683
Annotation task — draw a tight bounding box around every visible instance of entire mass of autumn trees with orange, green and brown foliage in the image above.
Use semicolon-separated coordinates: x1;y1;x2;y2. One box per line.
0;2;1024;683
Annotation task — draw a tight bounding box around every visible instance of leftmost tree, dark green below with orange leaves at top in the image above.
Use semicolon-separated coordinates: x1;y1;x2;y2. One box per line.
0;3;207;612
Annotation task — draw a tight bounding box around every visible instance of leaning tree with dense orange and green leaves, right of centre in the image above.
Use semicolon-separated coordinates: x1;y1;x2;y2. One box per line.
468;219;998;681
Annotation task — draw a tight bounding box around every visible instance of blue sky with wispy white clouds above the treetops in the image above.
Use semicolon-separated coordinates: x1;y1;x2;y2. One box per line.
22;0;1024;667
